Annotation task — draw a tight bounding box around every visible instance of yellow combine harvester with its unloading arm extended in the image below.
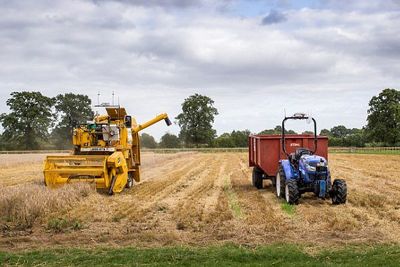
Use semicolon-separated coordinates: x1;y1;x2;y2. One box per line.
43;106;171;195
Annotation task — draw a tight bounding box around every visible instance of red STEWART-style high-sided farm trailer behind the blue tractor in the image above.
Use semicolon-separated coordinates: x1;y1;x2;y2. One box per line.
249;134;328;179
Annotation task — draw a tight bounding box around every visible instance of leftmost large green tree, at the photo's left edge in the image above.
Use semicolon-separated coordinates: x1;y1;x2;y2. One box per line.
0;92;54;149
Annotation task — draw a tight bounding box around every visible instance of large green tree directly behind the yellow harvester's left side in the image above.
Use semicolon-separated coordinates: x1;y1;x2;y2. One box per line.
52;93;94;149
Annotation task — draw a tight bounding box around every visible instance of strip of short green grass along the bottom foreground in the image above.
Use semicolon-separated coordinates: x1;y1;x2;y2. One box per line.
0;246;400;267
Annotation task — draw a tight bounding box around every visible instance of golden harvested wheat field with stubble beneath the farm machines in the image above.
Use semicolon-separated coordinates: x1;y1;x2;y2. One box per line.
0;152;400;250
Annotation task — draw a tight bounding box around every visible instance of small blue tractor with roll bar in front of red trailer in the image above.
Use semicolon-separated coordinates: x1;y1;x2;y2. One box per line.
273;113;347;205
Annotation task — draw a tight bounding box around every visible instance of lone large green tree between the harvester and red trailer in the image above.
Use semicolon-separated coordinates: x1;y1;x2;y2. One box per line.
175;94;218;146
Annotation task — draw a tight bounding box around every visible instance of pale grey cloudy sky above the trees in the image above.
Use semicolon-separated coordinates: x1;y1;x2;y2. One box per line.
0;0;400;138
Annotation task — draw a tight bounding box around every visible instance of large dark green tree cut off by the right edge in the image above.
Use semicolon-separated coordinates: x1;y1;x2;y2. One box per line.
366;89;400;145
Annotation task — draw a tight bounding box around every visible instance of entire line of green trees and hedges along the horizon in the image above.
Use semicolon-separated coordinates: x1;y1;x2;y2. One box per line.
0;89;400;150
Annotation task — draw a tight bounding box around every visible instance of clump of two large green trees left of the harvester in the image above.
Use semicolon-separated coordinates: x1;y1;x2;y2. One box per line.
0;92;94;150
